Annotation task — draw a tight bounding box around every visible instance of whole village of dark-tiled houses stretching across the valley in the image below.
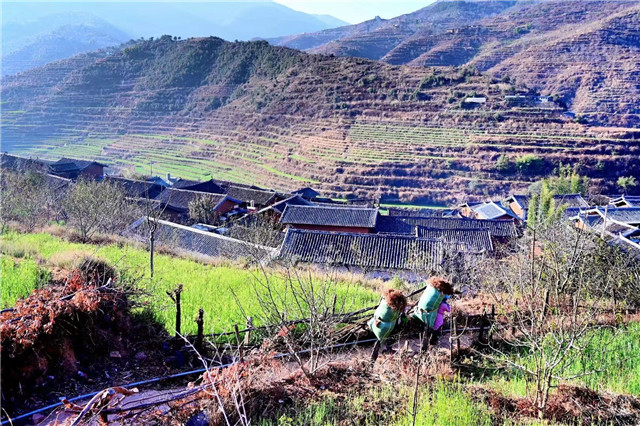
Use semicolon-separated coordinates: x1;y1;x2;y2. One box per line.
1;154;640;279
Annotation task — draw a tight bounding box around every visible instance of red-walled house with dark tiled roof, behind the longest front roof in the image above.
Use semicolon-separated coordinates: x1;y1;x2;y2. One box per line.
280;205;378;234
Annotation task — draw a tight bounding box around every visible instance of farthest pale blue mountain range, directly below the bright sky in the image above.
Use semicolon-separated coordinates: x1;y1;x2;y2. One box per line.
2;0;345;40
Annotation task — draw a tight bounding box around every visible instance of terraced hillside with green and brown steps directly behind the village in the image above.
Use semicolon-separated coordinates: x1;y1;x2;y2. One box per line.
0;36;640;203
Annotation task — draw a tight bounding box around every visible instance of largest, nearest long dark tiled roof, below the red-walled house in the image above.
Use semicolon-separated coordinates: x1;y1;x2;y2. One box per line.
279;229;443;271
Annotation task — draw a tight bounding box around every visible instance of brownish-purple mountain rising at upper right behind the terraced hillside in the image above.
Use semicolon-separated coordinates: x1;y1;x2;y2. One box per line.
269;0;640;124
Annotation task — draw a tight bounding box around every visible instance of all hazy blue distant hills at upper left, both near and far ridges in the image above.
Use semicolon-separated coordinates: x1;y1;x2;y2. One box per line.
2;1;346;75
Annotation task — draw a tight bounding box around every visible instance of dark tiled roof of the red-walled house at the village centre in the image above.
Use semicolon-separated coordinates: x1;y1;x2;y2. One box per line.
280;206;378;228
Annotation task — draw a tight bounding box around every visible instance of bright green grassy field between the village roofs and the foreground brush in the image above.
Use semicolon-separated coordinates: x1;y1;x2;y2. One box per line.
0;233;379;334
